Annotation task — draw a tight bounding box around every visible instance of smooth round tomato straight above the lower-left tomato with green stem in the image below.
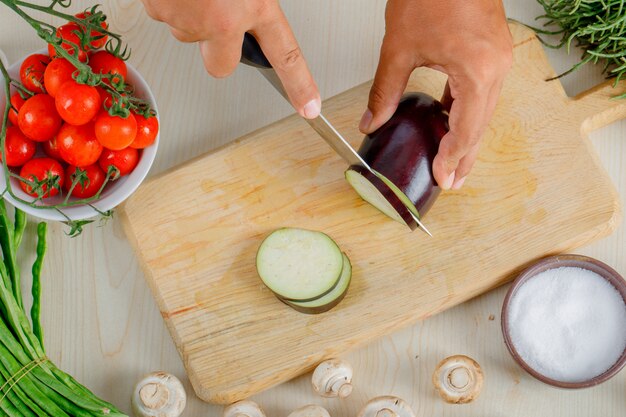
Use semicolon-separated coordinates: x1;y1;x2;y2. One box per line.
17;94;63;142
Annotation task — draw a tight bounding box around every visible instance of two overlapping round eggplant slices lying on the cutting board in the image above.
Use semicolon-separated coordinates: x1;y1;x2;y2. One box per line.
256;228;352;314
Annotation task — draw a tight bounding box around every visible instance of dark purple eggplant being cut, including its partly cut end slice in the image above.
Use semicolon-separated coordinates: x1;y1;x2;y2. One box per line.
345;93;449;229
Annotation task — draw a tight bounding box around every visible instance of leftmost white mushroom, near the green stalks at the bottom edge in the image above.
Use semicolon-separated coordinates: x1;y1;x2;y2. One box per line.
131;372;187;417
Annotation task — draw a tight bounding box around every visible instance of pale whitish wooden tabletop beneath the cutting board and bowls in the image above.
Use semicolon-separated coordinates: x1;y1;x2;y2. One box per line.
0;0;626;417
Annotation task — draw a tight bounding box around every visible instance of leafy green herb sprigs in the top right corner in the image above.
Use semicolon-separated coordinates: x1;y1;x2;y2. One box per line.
533;0;626;98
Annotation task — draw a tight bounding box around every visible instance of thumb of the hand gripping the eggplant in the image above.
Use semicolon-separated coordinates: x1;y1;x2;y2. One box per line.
359;36;416;133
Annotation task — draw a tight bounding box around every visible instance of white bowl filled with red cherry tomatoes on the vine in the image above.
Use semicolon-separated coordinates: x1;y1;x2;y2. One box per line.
0;42;159;221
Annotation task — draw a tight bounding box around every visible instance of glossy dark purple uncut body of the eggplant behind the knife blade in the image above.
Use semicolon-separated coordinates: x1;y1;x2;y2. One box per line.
359;93;449;217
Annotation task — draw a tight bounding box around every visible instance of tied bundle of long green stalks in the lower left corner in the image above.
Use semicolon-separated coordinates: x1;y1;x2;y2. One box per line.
0;204;125;417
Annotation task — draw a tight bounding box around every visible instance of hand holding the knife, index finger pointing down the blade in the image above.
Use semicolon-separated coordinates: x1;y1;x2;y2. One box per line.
142;0;321;118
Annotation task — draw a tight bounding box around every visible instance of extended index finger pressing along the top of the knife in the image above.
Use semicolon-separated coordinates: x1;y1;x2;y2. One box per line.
252;4;322;119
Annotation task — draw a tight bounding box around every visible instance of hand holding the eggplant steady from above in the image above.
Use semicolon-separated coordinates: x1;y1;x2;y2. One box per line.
359;0;513;189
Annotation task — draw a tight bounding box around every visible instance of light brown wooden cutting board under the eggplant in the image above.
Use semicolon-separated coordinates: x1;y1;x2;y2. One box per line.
122;25;626;404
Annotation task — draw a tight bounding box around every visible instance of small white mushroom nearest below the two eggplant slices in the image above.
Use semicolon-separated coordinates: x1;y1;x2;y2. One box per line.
311;359;352;398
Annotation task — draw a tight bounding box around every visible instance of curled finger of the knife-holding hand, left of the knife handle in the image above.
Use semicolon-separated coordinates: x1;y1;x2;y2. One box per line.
199;33;243;78
